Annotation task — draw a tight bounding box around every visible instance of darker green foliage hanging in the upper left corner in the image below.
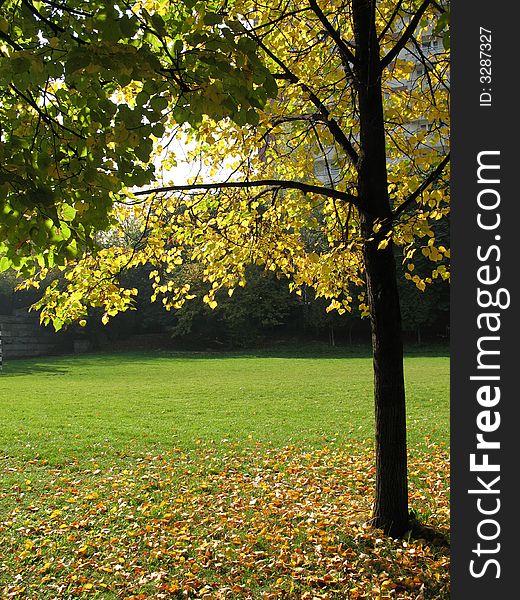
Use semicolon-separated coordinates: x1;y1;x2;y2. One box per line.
0;0;277;275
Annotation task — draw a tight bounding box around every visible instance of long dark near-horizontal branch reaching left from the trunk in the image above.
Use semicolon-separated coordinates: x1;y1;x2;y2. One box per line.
133;179;358;206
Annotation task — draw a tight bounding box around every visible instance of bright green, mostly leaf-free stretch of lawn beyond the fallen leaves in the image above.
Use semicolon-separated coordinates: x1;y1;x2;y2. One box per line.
0;352;449;463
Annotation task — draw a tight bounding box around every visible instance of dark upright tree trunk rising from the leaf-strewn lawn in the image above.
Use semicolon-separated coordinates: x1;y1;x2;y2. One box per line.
352;0;409;536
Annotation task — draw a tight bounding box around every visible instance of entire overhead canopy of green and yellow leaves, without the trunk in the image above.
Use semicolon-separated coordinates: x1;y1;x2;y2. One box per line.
2;1;449;326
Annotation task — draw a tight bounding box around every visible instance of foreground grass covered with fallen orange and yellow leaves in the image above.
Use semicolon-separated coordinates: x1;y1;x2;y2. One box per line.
0;441;449;600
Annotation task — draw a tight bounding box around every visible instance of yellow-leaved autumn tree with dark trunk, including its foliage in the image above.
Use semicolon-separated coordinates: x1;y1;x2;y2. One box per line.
2;0;449;535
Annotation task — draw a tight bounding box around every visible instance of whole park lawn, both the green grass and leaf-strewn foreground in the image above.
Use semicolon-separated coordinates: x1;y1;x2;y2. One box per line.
0;349;449;600
